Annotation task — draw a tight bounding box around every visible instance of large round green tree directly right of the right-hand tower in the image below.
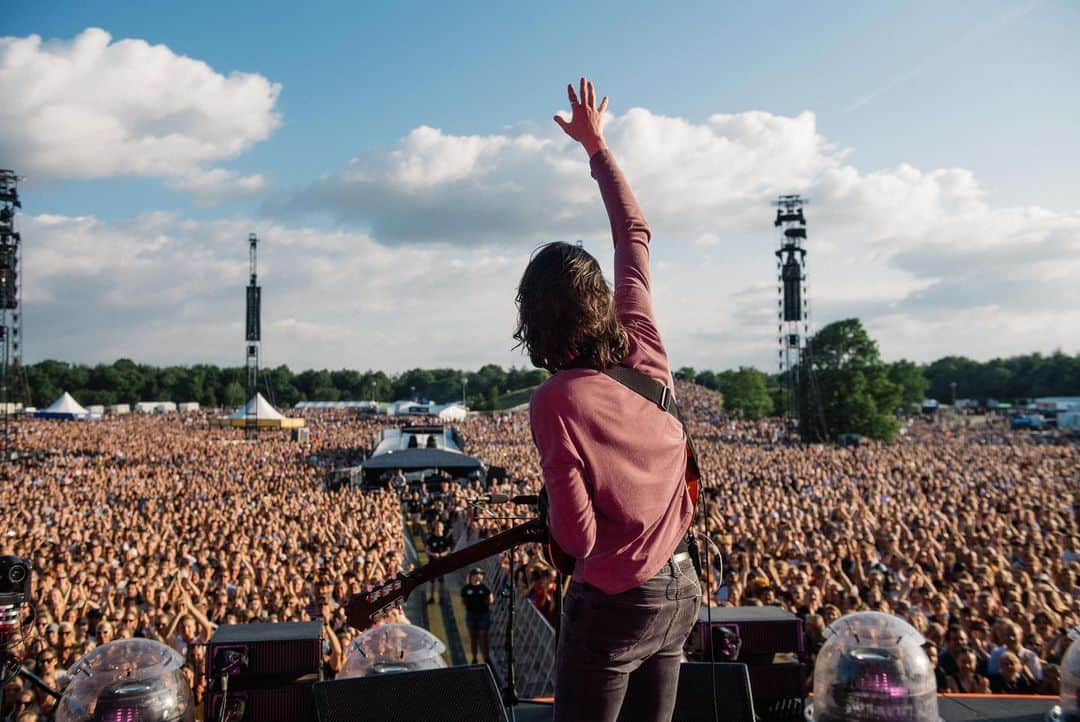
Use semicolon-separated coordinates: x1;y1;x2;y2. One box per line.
799;318;902;441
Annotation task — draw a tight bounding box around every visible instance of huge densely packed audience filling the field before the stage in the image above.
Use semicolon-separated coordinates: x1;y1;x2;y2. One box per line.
0;384;1080;722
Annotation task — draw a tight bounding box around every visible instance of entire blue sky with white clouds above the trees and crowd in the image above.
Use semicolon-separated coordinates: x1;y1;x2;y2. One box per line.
0;0;1080;370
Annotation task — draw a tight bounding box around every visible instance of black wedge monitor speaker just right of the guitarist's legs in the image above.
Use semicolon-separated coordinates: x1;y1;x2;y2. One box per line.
672;662;756;722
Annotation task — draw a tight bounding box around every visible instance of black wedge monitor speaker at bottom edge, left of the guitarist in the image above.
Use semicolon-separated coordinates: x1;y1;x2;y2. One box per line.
315;665;507;722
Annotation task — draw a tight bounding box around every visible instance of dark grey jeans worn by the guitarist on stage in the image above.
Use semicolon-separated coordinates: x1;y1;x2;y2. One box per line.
555;559;701;722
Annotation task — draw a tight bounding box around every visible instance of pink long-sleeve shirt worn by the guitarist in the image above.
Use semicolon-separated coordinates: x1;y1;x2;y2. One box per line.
529;150;693;594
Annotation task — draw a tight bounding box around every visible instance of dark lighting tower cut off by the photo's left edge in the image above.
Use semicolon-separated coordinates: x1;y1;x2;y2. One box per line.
0;169;23;459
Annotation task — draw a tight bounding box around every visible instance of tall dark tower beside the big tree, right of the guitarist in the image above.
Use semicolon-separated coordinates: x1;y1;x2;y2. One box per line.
773;195;810;420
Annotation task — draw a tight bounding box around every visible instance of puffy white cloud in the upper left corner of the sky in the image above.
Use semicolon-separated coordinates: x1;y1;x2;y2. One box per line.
0;28;281;179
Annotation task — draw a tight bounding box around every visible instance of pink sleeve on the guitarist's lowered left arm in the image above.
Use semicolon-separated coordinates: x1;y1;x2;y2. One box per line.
529;394;596;559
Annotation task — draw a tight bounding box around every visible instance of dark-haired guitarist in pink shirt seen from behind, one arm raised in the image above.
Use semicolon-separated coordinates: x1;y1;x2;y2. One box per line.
514;78;701;722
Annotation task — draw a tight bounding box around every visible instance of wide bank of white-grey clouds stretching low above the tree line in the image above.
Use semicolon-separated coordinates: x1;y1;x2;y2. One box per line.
10;90;1080;370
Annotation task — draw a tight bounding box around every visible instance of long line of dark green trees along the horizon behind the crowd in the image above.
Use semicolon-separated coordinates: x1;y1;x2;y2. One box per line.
10;318;1080;439
